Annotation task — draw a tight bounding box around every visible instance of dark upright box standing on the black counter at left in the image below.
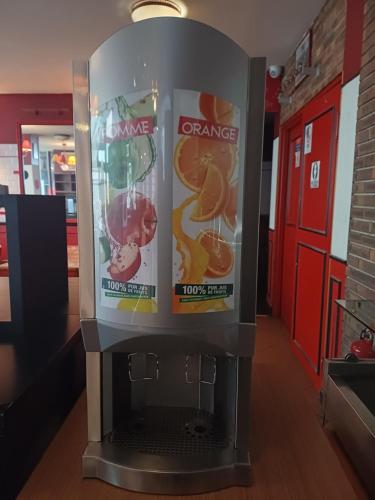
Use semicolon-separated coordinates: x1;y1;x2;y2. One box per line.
0;195;68;340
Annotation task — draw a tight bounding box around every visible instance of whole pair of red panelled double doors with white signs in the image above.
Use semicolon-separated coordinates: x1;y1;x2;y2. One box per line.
278;79;341;387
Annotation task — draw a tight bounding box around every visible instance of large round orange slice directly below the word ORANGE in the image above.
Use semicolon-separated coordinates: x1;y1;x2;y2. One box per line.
174;136;236;192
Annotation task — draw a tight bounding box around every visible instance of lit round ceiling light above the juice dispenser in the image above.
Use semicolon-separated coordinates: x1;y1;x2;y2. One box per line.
130;0;187;22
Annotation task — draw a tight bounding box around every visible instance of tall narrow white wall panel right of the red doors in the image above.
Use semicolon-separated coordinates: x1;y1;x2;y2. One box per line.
331;76;359;261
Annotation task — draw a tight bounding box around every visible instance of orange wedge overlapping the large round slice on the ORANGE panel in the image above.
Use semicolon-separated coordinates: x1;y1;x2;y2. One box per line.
190;165;227;222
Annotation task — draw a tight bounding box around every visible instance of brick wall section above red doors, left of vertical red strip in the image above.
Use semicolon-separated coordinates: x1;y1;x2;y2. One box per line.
281;0;346;123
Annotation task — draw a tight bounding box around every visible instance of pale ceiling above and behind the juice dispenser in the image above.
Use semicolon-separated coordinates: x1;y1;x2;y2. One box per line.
0;0;325;94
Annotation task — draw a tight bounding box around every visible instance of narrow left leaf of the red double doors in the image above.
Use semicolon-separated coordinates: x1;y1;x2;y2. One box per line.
281;124;302;331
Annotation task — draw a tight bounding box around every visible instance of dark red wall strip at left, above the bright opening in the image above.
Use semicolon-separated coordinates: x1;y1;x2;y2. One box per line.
0;94;73;144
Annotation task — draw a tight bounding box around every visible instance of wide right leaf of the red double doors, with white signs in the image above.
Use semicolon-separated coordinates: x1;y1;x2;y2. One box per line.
292;84;340;385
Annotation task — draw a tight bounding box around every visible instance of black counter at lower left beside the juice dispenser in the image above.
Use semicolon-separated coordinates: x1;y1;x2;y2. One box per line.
0;316;85;500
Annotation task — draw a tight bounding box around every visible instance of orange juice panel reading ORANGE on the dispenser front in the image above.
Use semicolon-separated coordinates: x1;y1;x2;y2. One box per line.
172;89;240;314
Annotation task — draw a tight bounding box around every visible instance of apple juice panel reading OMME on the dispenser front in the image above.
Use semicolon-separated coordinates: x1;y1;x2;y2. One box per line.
91;90;158;313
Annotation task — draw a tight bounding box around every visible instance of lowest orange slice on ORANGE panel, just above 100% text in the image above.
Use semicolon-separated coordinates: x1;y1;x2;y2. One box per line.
198;229;233;278
